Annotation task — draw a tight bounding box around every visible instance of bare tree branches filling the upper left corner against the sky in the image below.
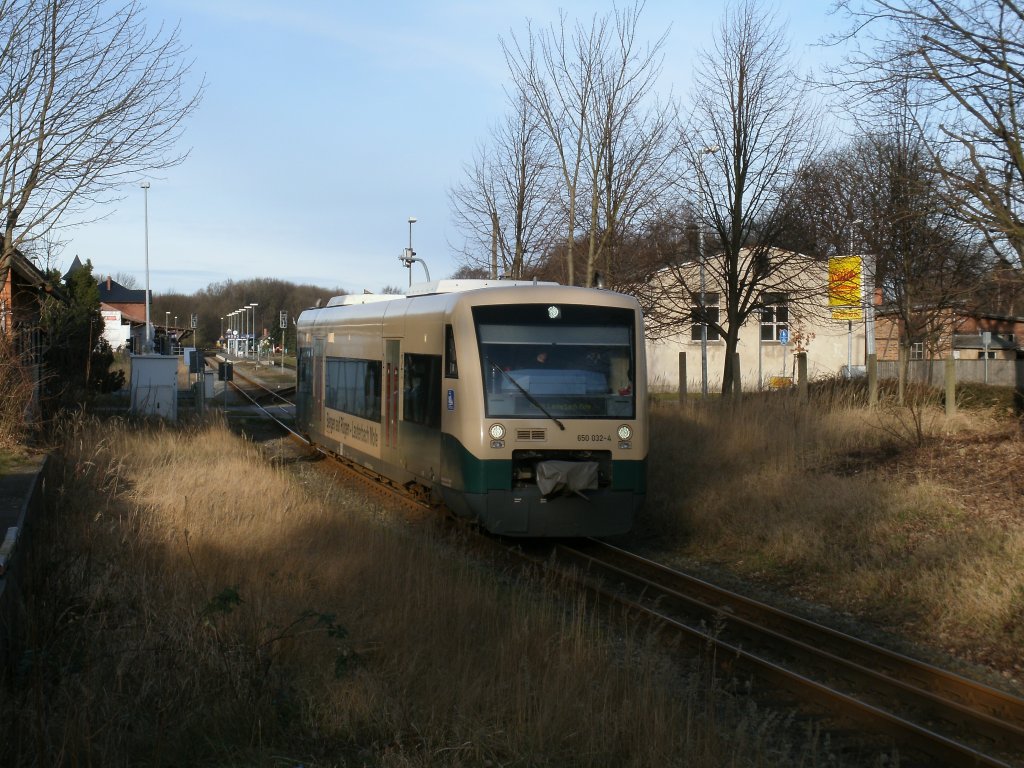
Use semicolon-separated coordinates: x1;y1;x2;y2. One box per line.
0;0;202;262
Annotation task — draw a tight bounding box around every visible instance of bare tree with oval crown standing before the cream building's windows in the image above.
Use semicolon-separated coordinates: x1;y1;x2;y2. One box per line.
662;0;818;392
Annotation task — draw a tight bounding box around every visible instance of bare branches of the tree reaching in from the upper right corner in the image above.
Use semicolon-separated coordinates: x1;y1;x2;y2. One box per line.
838;0;1024;267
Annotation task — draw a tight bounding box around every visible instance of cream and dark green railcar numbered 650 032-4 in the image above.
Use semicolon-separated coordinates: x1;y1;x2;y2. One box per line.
296;280;648;538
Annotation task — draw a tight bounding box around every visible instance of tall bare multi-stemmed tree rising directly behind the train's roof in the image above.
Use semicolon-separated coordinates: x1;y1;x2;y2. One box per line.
503;4;669;286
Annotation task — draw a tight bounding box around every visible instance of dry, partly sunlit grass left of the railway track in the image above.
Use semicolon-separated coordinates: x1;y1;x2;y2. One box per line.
0;422;790;768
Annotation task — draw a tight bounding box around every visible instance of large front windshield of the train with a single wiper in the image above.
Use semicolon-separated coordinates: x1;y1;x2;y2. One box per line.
473;304;636;419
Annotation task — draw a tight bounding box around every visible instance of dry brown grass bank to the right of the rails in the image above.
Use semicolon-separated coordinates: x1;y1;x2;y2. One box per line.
648;393;1024;682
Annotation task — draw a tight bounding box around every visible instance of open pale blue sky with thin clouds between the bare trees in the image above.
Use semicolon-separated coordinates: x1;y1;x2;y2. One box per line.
58;0;841;294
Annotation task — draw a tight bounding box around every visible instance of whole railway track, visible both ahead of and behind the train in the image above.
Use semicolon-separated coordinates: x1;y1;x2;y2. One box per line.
214;354;1024;768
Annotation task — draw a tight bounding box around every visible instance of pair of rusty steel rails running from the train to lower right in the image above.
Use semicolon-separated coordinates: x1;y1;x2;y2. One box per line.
548;540;1024;768
